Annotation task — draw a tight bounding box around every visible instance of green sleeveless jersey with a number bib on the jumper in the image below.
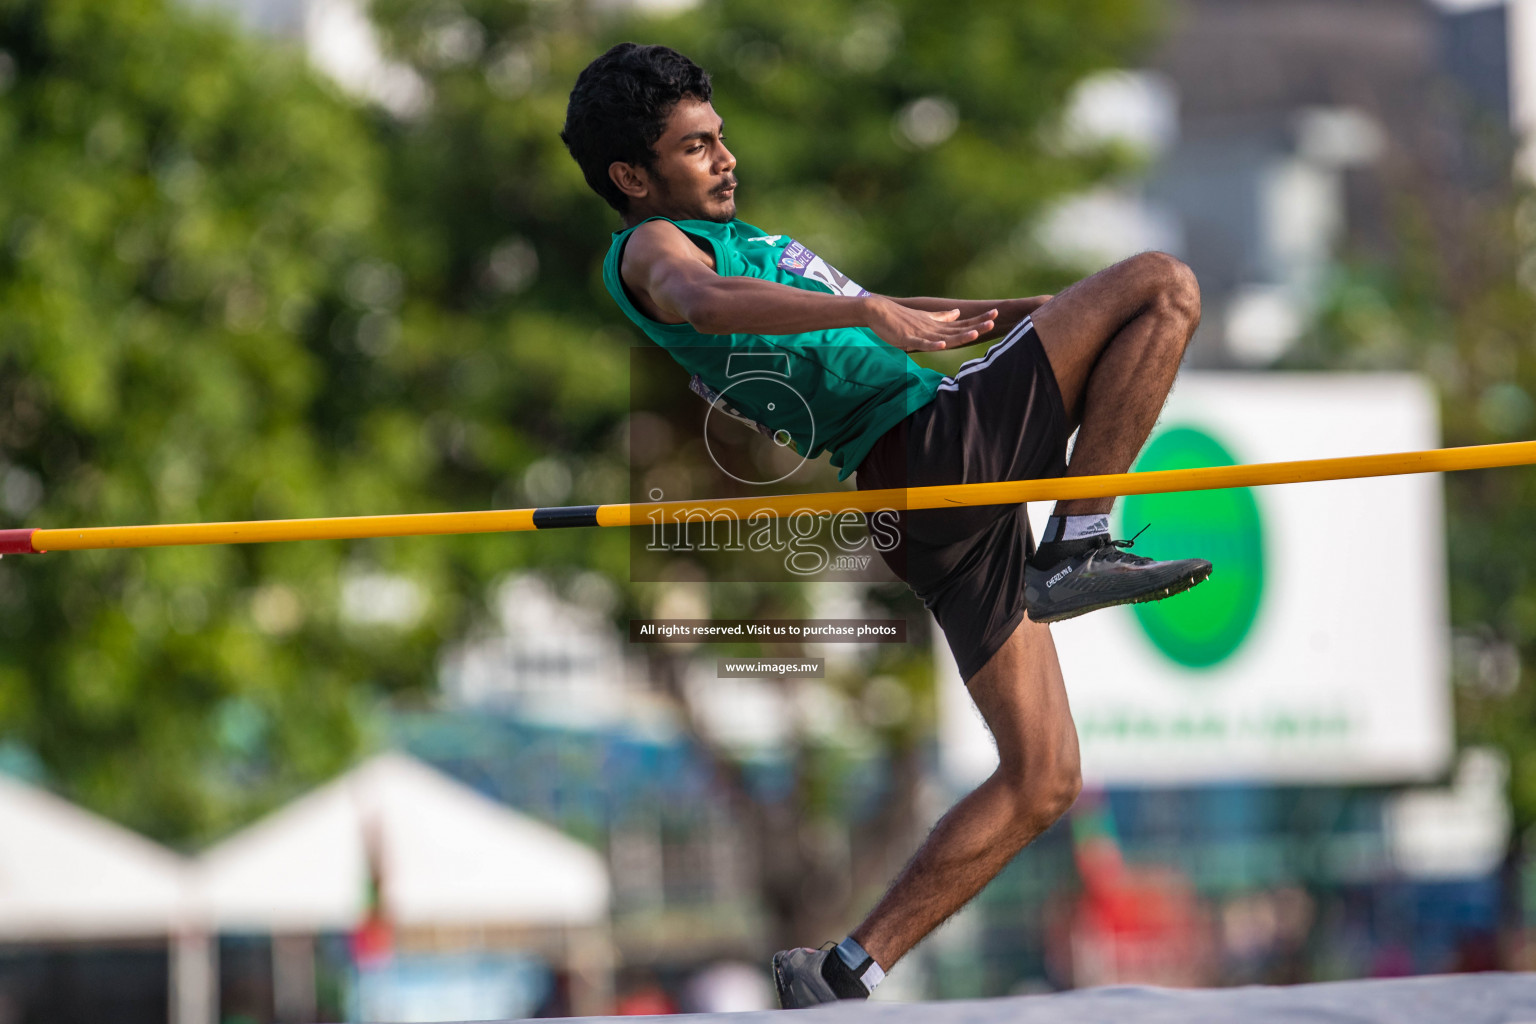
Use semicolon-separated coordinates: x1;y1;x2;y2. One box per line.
602;218;945;481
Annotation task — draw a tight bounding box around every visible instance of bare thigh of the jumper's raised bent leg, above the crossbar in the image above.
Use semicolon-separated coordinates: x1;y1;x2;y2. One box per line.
1031;252;1172;425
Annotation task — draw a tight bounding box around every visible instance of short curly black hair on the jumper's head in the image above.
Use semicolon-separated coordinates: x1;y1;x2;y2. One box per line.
561;43;710;213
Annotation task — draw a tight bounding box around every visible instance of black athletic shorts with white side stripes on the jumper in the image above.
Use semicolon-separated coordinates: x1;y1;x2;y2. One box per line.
857;318;1071;682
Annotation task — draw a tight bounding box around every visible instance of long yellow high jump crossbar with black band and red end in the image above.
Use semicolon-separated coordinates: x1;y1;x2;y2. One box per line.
0;441;1536;554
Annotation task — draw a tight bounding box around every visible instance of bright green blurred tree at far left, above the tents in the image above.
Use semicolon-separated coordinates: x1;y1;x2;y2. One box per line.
0;0;455;840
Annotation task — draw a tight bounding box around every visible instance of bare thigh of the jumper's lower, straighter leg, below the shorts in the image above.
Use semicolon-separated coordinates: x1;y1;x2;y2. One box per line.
966;616;1078;775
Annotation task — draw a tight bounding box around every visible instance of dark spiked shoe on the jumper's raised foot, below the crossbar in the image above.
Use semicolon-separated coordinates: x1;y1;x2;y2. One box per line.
1025;534;1210;622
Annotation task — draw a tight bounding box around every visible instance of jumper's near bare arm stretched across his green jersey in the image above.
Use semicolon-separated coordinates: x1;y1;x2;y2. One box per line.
619;221;997;352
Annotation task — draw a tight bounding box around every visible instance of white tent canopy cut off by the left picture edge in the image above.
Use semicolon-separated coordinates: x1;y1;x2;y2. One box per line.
0;775;187;941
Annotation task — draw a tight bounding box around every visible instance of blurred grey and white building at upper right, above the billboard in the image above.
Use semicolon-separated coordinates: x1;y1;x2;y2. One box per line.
1038;0;1536;367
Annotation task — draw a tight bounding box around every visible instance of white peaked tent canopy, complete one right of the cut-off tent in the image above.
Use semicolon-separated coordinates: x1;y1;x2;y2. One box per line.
195;754;610;932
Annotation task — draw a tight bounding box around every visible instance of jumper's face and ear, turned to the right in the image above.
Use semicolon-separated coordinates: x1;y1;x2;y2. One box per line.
611;97;736;223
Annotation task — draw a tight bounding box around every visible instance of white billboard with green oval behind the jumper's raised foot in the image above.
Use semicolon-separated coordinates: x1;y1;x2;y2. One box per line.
935;373;1453;786
